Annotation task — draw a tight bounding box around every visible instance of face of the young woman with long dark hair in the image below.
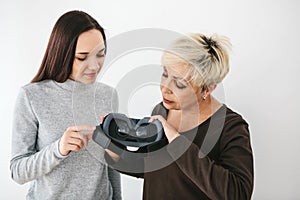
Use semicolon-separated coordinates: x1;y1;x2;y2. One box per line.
70;29;105;84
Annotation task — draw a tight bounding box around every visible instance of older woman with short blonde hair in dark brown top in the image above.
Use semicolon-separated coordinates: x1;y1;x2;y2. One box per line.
106;34;253;200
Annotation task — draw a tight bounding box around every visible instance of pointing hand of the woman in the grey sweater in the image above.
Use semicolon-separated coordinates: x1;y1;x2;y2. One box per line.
59;125;96;156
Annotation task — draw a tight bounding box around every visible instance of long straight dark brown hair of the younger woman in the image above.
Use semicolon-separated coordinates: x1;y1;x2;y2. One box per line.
31;11;106;83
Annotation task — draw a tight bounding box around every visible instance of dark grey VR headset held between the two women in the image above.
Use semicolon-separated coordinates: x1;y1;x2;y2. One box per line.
93;113;164;153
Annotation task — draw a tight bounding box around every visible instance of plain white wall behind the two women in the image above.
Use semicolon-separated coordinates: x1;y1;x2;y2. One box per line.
0;0;300;200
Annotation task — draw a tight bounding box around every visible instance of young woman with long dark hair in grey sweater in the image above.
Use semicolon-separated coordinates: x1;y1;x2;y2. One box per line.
10;11;121;199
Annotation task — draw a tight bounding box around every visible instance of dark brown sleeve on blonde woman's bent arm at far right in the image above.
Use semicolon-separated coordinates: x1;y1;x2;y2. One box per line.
168;116;253;200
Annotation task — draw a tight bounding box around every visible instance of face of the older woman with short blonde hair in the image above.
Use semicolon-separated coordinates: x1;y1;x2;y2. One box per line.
160;62;199;110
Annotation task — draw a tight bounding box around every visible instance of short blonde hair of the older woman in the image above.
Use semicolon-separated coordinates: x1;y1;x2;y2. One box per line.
162;33;231;92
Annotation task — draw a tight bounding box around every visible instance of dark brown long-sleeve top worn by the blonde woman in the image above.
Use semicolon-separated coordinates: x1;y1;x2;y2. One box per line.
106;103;253;200
